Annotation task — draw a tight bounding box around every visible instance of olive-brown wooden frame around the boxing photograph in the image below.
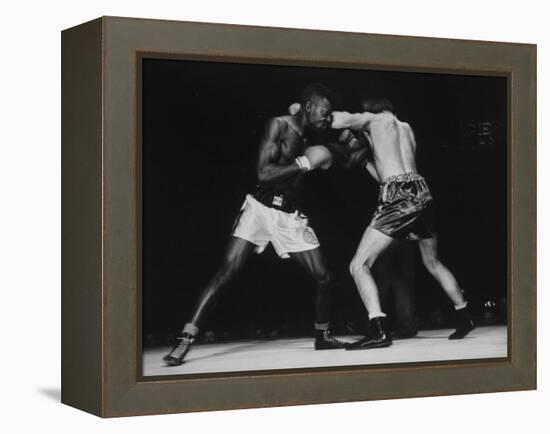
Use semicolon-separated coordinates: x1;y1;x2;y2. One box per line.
62;17;536;417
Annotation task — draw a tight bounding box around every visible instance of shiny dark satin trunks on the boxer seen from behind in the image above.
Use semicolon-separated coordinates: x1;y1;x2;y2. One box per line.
370;173;435;240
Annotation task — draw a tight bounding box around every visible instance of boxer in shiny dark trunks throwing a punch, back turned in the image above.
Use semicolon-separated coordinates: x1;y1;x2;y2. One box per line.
332;98;475;350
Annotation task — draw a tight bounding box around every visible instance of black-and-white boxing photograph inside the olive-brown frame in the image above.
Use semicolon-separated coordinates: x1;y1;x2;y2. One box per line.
138;57;508;377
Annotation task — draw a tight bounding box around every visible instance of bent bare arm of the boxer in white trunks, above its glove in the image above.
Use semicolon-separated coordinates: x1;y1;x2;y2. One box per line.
257;119;301;183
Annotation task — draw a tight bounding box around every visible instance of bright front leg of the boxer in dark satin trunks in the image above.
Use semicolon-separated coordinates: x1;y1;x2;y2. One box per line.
350;226;392;318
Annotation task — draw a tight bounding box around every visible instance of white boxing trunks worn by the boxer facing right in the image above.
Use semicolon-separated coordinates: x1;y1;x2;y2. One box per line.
233;195;319;259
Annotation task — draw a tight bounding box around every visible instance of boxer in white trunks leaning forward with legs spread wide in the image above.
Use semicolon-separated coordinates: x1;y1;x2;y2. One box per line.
163;85;352;366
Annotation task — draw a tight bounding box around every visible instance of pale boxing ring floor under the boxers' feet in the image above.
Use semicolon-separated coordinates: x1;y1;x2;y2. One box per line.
143;326;507;376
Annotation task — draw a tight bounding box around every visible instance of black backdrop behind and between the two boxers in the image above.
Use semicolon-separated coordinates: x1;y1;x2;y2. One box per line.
142;59;507;345
